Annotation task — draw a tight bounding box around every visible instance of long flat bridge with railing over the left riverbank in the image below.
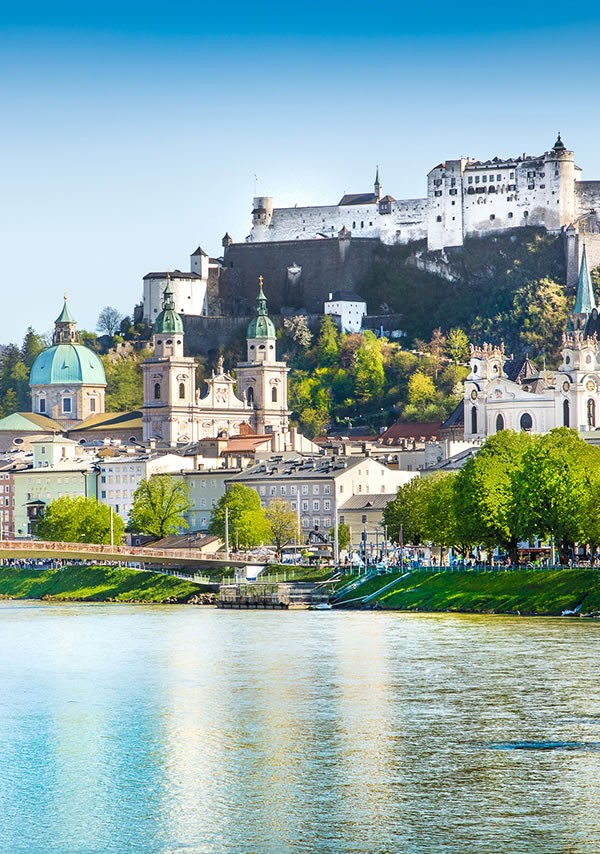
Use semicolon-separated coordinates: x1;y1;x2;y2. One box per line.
0;540;265;569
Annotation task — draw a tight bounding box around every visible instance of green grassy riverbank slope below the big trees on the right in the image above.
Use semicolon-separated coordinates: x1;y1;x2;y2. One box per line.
341;569;600;616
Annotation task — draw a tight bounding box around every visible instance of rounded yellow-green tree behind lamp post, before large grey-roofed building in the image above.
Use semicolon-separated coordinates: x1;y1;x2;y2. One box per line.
208;483;271;549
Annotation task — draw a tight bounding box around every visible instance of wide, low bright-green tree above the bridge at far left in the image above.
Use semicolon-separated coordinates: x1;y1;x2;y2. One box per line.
34;495;125;543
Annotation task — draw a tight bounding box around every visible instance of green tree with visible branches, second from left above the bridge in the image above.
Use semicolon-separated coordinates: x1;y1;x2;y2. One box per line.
127;474;191;537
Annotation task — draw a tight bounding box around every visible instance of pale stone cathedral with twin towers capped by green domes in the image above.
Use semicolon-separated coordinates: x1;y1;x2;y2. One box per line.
142;277;289;446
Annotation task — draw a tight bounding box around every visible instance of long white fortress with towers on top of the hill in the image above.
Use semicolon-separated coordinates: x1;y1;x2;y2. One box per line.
247;134;600;250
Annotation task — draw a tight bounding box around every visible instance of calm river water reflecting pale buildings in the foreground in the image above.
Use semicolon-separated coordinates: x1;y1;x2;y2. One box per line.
0;602;600;854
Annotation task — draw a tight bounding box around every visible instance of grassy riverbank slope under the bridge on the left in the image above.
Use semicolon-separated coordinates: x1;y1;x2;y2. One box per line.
0;566;208;603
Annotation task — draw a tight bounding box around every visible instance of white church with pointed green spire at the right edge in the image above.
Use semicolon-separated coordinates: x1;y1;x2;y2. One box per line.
464;246;600;442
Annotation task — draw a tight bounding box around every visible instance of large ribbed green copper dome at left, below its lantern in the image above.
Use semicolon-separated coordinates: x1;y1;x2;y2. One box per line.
29;344;106;385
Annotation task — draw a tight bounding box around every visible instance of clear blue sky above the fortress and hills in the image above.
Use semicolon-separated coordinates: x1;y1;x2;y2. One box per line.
0;0;600;343
